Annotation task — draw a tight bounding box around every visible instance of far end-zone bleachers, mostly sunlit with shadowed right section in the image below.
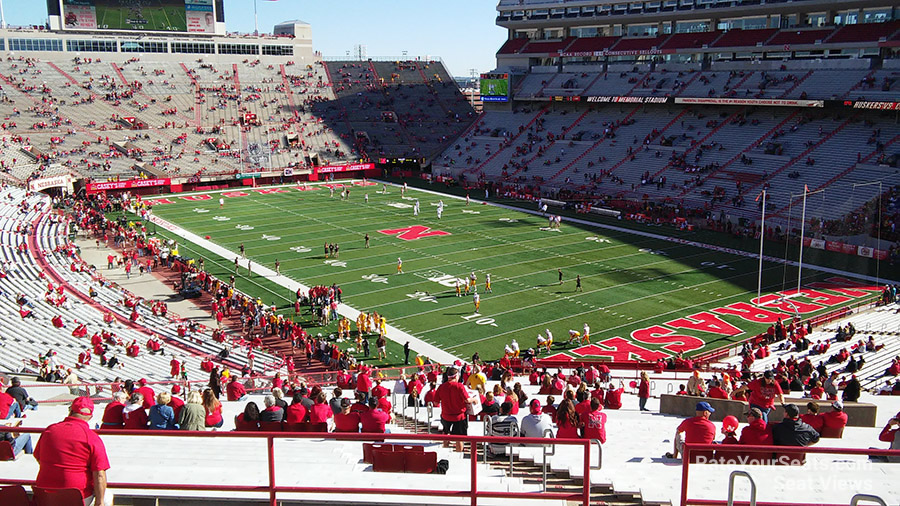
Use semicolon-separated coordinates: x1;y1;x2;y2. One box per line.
0;57;474;186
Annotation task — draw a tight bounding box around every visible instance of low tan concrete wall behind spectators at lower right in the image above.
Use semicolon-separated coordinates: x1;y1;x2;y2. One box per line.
659;394;878;427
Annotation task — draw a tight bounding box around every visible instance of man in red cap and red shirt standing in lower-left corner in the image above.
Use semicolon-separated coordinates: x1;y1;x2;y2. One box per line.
34;397;111;506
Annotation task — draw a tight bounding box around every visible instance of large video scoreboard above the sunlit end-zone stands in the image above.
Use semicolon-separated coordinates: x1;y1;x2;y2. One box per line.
60;0;215;33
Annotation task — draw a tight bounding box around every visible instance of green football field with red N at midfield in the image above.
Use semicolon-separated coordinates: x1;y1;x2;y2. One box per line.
137;183;875;362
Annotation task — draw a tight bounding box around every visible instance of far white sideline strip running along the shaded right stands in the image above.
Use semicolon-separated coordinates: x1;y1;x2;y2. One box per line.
390;179;900;284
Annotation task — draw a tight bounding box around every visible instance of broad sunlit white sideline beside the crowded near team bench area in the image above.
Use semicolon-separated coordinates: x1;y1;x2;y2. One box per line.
150;213;461;364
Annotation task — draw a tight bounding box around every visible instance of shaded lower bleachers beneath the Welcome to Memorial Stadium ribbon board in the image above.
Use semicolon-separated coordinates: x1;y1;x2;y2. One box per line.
436;88;900;226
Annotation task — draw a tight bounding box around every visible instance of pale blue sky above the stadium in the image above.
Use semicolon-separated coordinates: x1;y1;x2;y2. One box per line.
3;0;506;76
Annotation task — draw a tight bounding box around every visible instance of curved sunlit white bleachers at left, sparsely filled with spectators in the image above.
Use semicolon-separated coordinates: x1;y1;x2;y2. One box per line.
0;188;278;382
